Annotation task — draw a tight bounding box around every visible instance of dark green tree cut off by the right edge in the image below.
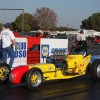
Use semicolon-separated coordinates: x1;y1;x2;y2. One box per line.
80;13;100;31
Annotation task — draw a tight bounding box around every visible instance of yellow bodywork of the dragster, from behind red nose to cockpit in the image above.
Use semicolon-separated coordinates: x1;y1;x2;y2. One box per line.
29;55;90;80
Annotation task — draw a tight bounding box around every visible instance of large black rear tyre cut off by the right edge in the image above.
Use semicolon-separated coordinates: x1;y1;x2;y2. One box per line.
90;59;100;81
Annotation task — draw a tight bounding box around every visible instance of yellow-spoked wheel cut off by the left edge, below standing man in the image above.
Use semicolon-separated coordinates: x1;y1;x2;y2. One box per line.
0;63;11;81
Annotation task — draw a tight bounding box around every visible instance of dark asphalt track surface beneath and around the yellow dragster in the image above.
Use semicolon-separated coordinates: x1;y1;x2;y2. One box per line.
0;42;100;100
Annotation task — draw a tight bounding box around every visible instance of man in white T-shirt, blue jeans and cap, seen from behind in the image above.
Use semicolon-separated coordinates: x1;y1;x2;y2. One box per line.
0;23;17;68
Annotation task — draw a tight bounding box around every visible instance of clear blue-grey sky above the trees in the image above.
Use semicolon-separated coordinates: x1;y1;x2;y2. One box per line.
0;0;100;29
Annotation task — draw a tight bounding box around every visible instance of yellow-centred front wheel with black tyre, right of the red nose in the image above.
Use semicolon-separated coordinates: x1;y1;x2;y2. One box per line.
25;68;43;90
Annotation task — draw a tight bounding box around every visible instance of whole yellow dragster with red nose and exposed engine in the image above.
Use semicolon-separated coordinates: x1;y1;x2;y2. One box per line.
0;42;100;90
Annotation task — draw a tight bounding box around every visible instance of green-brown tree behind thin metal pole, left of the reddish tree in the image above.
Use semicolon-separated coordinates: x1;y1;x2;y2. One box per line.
12;13;33;32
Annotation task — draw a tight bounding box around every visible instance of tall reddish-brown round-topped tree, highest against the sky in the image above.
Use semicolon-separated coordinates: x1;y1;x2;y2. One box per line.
34;7;57;30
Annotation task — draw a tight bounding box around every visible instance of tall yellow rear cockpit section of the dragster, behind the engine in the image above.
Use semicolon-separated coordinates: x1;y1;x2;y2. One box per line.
66;55;90;73
